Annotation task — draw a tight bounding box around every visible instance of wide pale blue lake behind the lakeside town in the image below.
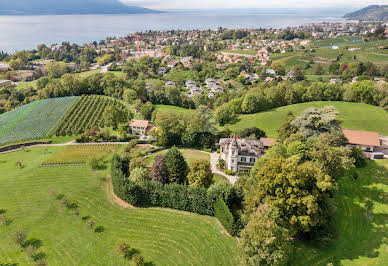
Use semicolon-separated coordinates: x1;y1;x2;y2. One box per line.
0;9;352;52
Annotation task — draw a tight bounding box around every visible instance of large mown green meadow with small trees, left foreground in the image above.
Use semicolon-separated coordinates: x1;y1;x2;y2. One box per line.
0;147;237;265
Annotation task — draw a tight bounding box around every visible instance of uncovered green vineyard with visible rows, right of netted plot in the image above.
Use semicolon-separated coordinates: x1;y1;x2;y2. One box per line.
55;95;125;136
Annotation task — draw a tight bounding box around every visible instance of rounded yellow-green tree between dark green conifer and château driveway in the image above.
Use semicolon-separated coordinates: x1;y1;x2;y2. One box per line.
187;160;213;188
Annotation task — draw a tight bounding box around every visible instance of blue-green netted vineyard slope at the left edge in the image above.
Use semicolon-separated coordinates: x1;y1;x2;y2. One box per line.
0;97;78;144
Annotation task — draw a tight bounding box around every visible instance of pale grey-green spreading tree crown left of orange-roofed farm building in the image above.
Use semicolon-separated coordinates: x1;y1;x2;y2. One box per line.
291;106;342;138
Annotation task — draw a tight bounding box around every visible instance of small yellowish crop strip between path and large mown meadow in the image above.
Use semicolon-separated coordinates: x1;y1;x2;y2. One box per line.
43;144;120;165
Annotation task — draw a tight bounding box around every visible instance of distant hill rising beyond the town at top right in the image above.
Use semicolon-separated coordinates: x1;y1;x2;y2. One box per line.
344;5;388;21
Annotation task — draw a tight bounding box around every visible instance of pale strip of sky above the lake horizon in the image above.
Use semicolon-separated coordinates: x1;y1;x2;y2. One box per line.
119;0;388;10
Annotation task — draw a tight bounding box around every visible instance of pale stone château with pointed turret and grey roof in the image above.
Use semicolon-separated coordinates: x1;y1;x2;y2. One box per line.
219;136;265;172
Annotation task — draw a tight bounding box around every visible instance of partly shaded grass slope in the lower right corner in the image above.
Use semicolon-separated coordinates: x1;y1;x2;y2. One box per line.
291;160;388;265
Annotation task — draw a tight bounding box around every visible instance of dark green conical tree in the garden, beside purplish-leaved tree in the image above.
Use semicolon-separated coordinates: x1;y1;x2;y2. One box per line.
165;146;188;184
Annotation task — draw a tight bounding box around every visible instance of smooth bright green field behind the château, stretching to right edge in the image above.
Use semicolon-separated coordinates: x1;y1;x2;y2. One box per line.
229;102;388;138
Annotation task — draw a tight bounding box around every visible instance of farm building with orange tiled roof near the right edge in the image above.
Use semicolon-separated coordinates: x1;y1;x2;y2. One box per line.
342;129;381;153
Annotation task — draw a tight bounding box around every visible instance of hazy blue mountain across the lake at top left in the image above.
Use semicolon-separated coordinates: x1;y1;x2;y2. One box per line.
0;0;160;15
